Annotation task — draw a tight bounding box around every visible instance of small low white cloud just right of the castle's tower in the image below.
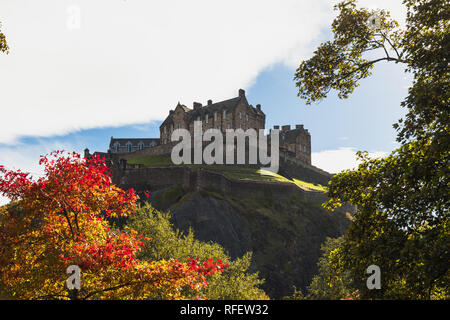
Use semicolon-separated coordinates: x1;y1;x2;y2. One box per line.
311;147;388;173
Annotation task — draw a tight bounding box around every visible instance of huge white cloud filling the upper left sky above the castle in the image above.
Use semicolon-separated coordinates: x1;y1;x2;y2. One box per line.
0;0;406;143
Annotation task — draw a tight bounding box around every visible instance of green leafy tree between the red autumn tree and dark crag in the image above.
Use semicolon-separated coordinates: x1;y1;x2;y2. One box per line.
127;203;268;300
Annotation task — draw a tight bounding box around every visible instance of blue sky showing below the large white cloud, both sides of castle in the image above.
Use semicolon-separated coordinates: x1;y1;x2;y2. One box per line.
0;59;410;171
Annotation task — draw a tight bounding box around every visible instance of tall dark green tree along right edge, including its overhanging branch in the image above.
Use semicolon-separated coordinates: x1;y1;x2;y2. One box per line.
295;0;450;299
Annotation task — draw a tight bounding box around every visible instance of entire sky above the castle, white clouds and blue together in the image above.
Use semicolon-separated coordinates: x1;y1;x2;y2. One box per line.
0;0;411;202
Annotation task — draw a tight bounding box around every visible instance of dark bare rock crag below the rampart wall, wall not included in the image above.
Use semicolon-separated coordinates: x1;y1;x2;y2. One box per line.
151;187;350;299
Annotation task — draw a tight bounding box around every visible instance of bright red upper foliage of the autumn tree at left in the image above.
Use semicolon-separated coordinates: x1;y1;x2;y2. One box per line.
0;151;137;232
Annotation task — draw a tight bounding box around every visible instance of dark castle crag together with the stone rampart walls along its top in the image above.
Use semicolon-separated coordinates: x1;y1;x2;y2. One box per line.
113;160;354;299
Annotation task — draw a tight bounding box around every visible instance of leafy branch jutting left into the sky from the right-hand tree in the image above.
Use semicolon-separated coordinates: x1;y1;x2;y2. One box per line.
294;0;404;104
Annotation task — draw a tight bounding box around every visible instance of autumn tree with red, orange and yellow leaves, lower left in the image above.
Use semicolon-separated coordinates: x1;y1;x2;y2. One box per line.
0;151;224;299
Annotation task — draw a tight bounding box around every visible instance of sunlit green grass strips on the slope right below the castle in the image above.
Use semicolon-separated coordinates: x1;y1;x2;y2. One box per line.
127;155;327;192
